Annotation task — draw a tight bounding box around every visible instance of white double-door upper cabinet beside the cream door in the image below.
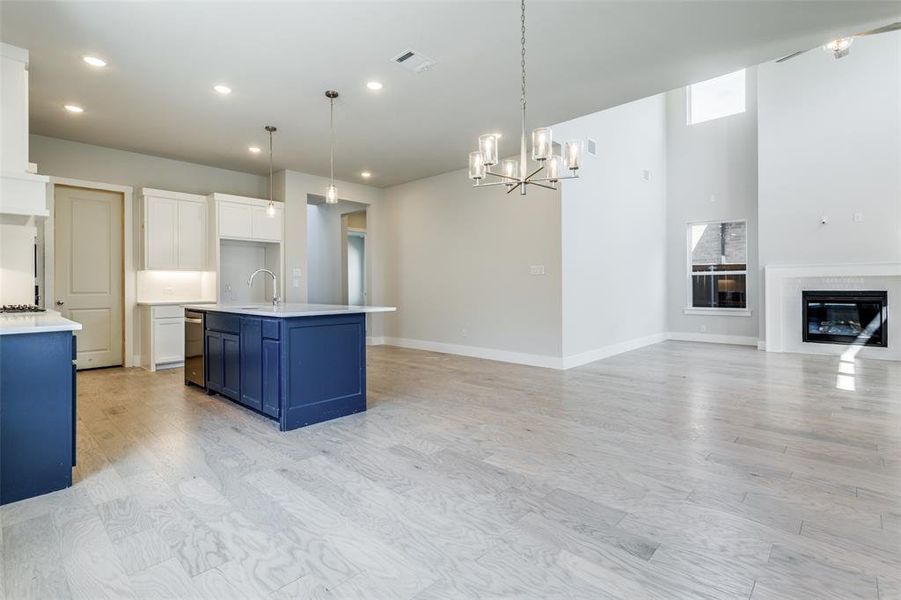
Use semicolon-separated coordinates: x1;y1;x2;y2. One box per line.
141;188;209;271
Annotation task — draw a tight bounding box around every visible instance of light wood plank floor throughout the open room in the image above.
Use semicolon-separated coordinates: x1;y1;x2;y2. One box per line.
0;342;901;600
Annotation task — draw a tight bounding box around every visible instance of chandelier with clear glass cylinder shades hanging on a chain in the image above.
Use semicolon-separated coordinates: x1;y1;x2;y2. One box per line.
469;0;582;196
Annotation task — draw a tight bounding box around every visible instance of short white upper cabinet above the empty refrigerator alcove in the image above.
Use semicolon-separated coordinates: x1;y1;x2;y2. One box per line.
211;193;284;243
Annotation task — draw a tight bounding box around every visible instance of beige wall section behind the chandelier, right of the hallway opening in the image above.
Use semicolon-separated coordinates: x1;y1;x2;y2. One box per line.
382;170;561;366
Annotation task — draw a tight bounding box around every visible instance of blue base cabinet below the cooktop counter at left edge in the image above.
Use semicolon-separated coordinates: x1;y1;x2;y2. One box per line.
0;331;75;504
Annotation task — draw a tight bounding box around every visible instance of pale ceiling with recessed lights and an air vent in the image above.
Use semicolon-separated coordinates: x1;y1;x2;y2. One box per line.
0;0;901;187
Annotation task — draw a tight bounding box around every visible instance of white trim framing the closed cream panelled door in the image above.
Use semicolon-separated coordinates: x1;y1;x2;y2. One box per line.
44;175;135;367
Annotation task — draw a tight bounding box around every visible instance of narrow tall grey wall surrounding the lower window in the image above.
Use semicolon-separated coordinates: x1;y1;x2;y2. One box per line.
666;67;762;343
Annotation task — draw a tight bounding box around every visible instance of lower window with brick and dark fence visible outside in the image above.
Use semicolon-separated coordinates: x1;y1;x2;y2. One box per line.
688;221;748;311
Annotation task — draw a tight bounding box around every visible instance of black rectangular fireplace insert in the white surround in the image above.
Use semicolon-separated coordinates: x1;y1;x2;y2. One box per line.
801;290;888;348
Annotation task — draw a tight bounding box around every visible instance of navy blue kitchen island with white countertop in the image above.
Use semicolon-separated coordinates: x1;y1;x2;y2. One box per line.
185;303;395;431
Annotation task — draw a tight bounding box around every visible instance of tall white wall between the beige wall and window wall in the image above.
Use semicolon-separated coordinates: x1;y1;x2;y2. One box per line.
553;95;666;364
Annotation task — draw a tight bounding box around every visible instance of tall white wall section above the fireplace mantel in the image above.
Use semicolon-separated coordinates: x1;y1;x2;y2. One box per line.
758;33;901;332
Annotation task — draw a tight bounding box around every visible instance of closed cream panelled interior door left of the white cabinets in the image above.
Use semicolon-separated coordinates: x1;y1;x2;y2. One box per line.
51;186;124;369
